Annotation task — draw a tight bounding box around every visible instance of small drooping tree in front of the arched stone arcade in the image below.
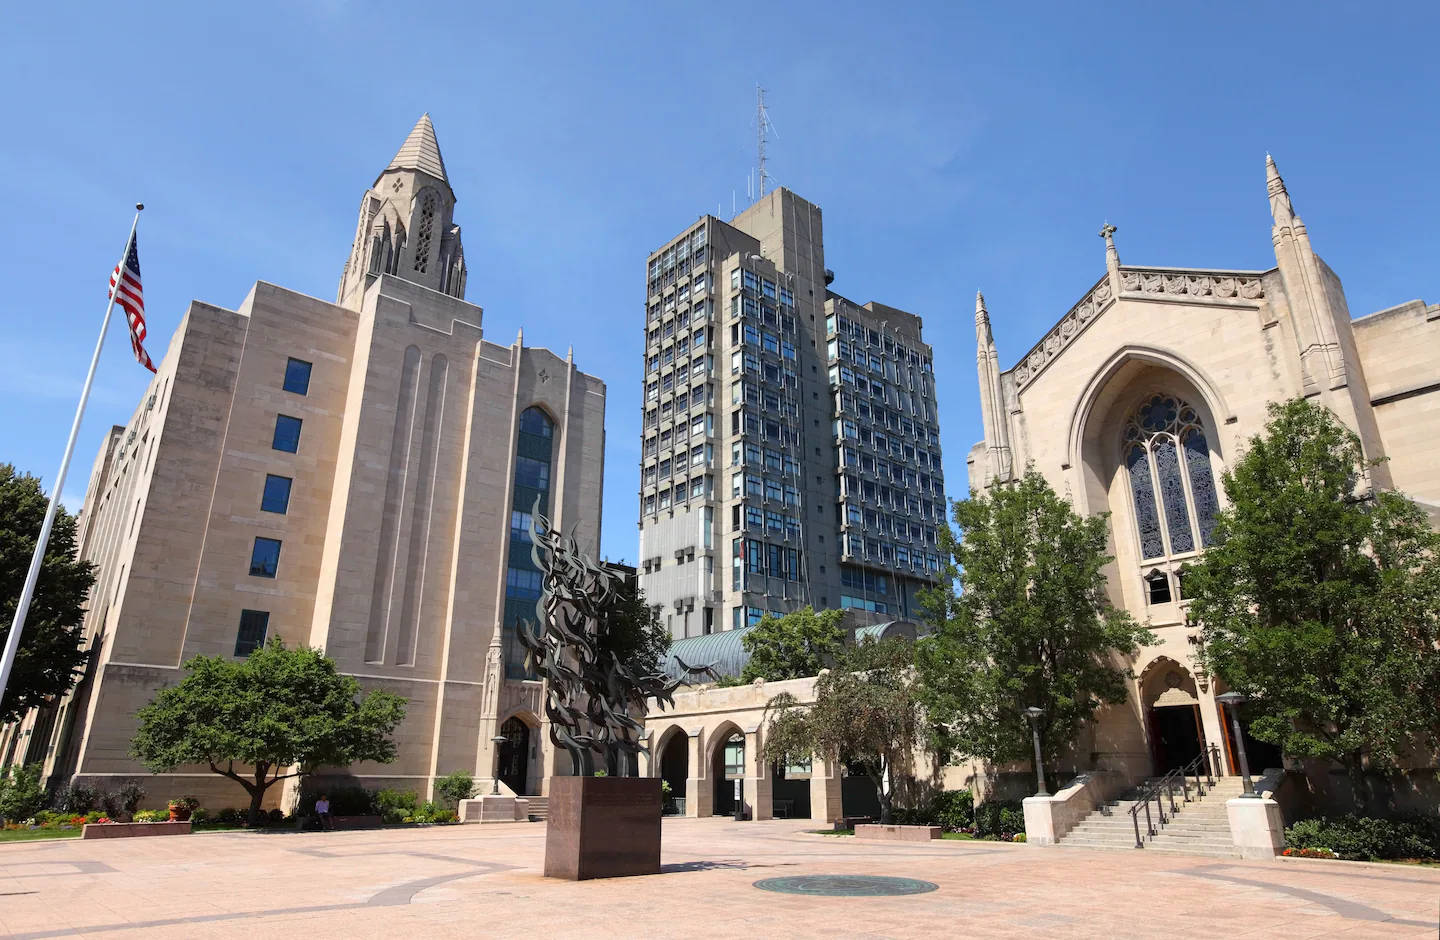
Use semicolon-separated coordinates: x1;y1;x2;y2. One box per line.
763;638;923;823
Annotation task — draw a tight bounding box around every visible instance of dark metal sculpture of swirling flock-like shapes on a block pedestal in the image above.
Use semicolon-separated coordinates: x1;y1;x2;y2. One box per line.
517;500;691;776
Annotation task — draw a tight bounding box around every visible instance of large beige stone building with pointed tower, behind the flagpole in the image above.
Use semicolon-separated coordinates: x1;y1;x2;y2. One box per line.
0;115;605;808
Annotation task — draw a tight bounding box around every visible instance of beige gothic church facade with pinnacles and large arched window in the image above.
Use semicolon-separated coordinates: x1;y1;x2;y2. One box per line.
968;157;1440;780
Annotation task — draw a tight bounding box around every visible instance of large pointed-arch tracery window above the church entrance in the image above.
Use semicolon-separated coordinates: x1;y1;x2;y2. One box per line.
1122;394;1220;560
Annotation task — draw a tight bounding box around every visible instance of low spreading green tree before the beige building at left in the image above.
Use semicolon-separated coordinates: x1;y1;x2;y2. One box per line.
131;638;405;825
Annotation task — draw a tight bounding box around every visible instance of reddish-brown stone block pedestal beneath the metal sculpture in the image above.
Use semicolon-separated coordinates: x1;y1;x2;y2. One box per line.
544;777;660;881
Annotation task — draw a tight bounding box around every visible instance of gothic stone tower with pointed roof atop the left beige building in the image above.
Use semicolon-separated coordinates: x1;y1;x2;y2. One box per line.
336;114;465;309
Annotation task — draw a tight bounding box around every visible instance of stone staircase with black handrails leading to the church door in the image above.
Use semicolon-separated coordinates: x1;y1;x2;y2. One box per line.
1058;777;1241;858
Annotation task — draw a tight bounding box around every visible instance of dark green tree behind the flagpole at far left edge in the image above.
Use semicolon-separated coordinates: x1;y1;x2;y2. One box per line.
0;464;95;724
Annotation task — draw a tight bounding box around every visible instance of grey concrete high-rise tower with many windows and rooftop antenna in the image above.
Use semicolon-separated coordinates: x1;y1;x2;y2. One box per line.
639;189;945;639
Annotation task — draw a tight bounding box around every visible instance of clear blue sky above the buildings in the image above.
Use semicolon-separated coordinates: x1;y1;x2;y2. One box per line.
0;0;1440;560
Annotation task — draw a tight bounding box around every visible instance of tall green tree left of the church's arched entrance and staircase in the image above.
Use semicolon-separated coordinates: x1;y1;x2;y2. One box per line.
916;468;1153;766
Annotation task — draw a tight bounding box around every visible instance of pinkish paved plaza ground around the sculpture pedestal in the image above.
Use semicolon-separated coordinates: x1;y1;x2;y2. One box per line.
0;819;1440;940
